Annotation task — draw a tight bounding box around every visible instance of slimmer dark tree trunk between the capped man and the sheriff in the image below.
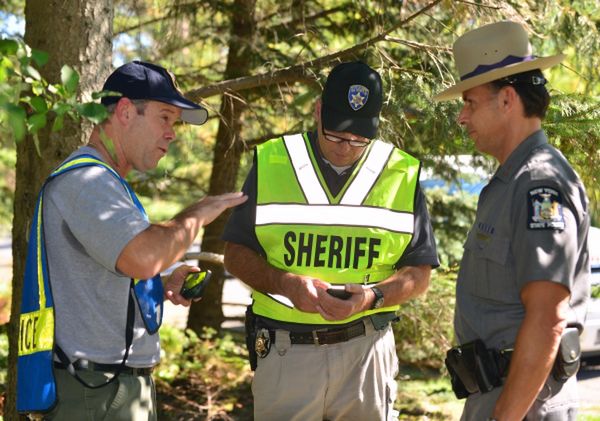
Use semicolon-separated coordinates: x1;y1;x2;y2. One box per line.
187;0;256;333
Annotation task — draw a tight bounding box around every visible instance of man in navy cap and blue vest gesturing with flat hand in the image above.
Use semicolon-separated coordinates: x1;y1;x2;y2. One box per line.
17;61;246;420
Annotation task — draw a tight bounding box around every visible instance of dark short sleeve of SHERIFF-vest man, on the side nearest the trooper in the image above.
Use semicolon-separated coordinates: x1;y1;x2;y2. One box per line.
396;184;440;269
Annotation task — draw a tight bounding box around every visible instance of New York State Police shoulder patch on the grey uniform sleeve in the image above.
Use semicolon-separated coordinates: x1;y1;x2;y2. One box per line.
527;187;565;231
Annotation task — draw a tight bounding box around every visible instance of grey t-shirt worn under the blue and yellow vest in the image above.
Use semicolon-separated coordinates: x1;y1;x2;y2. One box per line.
43;146;160;367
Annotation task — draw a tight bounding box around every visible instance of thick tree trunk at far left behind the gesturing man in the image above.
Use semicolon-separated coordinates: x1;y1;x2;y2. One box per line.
4;0;113;420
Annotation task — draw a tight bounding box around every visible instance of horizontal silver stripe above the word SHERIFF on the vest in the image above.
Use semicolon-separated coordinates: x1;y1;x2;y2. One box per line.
256;204;414;233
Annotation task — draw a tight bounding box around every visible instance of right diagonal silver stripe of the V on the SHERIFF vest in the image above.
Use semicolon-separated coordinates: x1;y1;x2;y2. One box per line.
340;141;394;205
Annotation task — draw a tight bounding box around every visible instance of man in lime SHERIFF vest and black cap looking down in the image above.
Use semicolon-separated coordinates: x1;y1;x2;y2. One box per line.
223;62;438;421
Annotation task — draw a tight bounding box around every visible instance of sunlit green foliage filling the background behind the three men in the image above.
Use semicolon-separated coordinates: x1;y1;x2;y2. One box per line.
0;0;600;378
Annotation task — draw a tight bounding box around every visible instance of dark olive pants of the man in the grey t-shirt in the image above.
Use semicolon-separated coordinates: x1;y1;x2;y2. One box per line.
44;369;156;421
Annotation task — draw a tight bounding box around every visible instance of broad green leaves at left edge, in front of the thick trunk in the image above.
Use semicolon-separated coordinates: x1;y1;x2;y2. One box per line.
0;38;106;227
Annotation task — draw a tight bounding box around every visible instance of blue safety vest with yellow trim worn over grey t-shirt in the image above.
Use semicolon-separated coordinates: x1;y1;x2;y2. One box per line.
17;155;163;412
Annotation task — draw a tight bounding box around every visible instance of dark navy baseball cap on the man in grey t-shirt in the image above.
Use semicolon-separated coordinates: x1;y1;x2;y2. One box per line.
102;61;208;125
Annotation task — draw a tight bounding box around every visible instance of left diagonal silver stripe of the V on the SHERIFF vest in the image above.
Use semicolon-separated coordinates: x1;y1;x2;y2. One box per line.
282;134;329;205
